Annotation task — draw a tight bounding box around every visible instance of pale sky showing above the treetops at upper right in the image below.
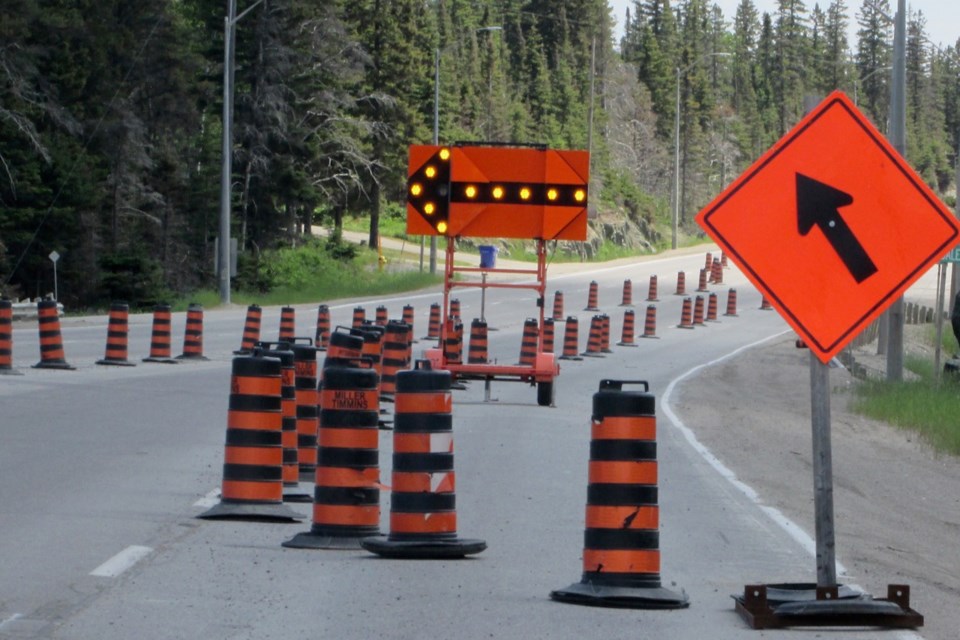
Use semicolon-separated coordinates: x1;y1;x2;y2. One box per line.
607;0;960;47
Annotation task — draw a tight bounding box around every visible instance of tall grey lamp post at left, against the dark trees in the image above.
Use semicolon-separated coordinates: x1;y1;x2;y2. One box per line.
217;0;263;304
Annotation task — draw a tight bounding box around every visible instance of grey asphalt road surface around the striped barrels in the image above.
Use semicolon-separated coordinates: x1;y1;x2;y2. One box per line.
0;252;928;640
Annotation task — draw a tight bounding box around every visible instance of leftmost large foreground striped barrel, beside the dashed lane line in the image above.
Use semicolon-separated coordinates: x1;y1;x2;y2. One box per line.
197;350;301;520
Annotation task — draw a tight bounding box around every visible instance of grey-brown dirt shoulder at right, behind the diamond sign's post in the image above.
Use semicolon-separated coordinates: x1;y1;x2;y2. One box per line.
673;334;960;640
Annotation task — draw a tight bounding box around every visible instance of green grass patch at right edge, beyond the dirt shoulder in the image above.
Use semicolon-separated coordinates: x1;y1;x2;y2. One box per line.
853;325;960;455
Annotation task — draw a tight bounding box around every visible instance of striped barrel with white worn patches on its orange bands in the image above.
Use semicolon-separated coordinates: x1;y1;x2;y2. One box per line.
360;361;487;559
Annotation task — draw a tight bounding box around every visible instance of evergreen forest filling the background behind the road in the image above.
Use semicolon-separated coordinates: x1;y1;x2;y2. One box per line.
0;0;960;307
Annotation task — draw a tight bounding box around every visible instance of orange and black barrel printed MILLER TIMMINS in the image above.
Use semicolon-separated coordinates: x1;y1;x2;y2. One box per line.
283;365;380;549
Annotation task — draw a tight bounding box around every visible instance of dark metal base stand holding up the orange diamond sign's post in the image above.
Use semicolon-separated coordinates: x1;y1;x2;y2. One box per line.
733;584;923;629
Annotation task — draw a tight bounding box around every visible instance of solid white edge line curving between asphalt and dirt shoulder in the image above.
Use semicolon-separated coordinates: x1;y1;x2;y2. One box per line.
660;329;923;640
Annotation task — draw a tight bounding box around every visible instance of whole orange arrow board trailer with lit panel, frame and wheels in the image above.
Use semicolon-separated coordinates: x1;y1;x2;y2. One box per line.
407;143;590;406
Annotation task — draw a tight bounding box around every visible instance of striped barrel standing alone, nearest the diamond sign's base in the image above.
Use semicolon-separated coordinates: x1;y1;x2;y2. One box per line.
550;380;689;609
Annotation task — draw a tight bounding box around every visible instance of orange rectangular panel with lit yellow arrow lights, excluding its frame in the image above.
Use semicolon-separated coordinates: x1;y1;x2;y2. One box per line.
407;145;590;240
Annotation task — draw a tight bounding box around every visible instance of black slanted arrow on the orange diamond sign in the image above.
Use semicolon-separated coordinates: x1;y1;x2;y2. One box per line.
797;173;877;284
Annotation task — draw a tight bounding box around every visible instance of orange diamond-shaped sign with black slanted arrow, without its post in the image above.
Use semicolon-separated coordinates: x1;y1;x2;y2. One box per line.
697;91;960;362
